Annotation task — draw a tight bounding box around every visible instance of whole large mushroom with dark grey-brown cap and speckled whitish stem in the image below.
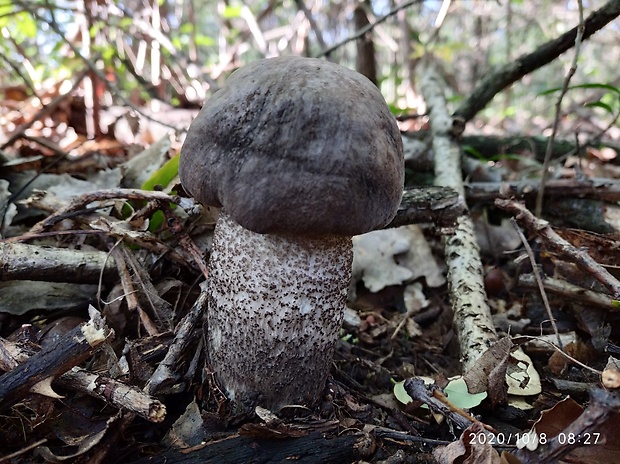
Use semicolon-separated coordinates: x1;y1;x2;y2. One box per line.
179;57;404;413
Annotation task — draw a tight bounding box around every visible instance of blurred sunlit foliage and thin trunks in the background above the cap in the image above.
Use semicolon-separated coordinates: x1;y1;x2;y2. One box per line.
0;0;620;138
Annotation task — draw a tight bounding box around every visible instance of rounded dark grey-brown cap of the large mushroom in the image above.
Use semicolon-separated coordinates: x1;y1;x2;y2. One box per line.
179;57;404;235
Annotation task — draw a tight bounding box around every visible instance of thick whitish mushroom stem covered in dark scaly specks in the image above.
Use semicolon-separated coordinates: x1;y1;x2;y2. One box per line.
205;210;353;413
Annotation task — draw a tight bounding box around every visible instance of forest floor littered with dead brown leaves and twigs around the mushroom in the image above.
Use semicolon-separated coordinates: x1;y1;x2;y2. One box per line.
0;94;620;464
